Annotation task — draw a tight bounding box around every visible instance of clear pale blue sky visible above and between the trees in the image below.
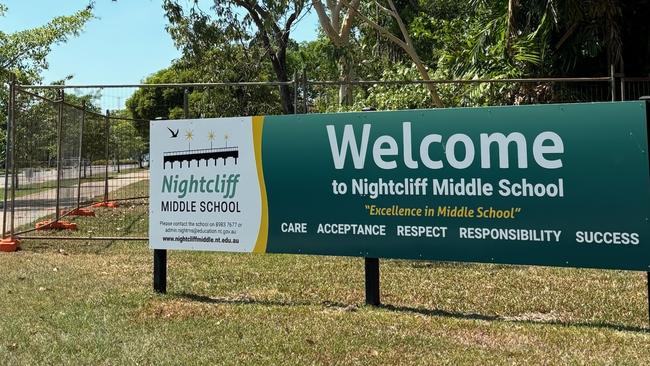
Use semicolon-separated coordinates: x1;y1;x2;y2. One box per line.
0;0;318;84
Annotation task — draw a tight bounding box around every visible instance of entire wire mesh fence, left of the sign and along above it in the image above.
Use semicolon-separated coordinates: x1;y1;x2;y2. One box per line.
0;75;650;240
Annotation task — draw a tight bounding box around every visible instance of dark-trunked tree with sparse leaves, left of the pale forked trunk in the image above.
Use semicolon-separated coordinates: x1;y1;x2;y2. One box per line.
164;0;307;113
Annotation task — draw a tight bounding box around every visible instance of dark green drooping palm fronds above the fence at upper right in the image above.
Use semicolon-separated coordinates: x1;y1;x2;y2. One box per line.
438;0;624;78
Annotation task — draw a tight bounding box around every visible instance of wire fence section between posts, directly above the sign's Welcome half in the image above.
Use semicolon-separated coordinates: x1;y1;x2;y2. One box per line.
301;77;616;113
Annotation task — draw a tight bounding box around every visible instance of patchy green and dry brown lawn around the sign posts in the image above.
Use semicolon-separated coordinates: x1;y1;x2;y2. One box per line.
0;189;650;365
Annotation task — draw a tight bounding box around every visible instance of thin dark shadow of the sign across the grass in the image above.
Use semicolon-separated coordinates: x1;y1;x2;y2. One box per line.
173;292;650;333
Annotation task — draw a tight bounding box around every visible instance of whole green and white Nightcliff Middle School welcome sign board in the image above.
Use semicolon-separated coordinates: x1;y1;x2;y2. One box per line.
149;102;650;271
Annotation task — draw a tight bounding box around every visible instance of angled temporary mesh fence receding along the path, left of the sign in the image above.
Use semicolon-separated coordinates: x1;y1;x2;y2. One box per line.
3;86;148;235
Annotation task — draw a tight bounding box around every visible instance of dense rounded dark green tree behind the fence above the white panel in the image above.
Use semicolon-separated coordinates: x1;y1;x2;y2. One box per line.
126;57;282;130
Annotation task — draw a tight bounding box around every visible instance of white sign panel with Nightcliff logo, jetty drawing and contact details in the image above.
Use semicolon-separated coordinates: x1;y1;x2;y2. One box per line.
149;117;262;252
